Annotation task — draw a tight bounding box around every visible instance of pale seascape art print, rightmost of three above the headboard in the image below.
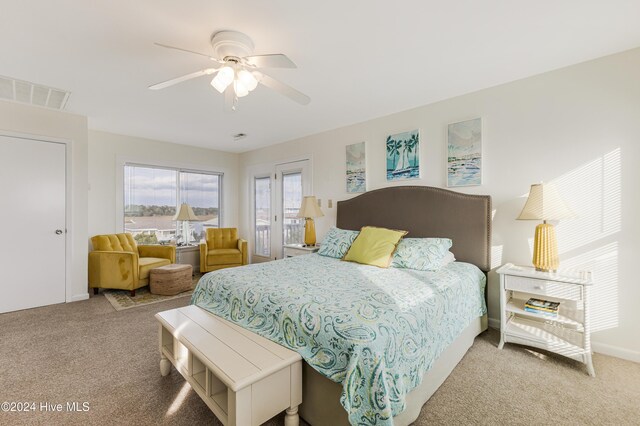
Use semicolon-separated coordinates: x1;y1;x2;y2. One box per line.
447;118;482;187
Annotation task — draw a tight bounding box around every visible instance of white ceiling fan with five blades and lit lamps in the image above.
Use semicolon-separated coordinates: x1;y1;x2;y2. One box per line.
149;31;311;111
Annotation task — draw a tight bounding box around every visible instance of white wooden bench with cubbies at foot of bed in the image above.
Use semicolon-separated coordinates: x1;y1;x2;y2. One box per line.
156;306;302;426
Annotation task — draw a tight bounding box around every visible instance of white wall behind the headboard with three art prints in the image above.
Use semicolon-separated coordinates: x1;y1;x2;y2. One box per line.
240;49;640;362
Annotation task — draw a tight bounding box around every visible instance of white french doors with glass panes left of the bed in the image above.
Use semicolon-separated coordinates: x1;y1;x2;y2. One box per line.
252;160;311;262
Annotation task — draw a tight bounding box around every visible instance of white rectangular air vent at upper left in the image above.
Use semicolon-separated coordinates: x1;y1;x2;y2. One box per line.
0;76;71;110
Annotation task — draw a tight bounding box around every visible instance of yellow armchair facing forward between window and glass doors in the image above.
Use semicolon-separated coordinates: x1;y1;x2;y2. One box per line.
200;228;248;273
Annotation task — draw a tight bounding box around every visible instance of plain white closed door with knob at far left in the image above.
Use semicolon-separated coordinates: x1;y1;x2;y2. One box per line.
0;136;66;313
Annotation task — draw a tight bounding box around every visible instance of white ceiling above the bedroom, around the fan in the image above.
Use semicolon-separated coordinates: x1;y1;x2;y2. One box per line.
0;0;640;152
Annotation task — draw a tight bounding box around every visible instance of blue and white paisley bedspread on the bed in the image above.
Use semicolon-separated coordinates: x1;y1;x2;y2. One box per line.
191;254;486;425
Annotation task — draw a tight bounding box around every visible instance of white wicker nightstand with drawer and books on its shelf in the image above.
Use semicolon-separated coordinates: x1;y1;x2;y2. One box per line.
496;263;596;377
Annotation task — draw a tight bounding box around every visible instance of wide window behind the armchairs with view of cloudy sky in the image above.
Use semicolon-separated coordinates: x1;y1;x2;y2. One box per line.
124;164;222;245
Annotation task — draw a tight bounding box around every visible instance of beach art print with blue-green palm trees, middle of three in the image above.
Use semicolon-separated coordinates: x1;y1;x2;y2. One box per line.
386;130;420;180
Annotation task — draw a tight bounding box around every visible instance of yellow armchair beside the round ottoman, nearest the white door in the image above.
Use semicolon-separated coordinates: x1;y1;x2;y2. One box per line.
89;233;176;297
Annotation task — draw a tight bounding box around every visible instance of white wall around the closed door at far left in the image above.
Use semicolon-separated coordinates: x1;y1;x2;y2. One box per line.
0;101;89;302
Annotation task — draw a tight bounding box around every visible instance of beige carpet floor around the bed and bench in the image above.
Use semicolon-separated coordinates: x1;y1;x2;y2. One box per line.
0;295;640;426
